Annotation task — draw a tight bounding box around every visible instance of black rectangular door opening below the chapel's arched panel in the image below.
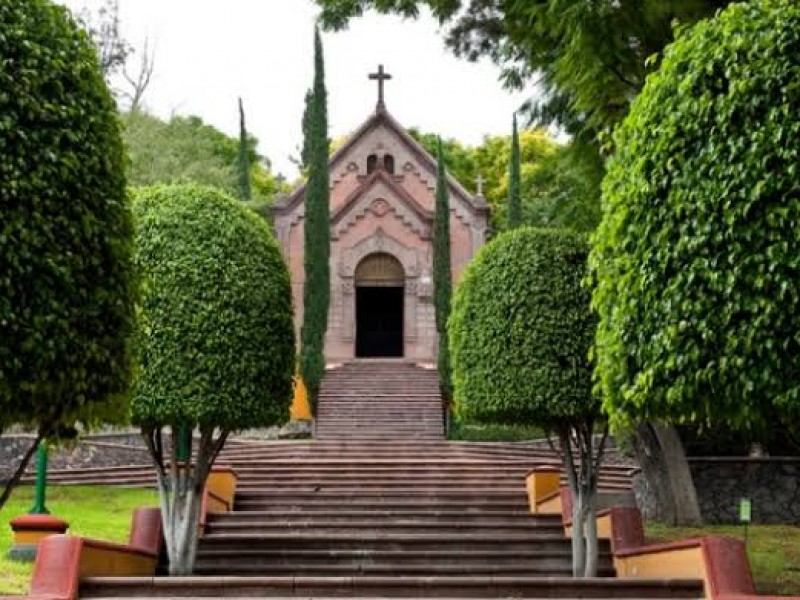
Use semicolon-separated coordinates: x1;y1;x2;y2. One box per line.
356;286;403;358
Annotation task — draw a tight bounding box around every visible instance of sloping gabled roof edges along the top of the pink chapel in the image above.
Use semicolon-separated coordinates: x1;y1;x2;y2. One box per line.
273;106;489;214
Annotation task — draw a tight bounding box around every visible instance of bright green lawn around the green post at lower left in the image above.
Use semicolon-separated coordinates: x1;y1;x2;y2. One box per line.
0;486;158;595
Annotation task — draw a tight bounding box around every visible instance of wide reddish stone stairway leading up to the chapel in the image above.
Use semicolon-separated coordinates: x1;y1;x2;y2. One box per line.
80;362;702;598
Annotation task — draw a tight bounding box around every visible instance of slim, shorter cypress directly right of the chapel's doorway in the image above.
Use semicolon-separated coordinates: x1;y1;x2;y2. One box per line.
433;138;453;401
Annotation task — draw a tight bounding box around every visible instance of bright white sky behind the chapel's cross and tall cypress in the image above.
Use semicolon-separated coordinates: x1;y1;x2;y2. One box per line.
61;0;530;179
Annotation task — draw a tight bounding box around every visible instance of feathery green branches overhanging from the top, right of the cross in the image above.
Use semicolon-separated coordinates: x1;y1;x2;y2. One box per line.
316;0;731;141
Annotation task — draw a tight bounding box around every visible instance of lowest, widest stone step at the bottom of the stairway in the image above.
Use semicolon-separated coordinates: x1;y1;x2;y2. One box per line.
80;576;703;599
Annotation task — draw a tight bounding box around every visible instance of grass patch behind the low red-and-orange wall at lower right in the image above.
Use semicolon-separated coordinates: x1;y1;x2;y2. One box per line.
646;523;800;596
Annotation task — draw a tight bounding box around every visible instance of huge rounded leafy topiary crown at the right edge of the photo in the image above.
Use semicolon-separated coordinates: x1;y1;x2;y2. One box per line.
591;0;800;520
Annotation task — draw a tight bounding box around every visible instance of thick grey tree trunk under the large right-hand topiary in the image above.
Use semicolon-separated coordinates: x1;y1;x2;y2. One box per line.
634;423;703;525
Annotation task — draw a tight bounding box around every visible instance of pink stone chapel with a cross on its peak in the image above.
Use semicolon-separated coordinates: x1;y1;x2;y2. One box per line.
274;66;489;364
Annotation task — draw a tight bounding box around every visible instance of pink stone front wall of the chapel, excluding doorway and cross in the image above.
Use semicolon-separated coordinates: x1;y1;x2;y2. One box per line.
275;116;488;363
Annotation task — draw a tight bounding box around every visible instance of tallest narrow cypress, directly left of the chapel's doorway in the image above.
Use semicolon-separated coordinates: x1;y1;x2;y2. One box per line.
300;29;330;402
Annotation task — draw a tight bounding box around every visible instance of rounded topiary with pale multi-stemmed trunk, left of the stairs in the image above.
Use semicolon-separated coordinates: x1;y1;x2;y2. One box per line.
132;185;295;575
